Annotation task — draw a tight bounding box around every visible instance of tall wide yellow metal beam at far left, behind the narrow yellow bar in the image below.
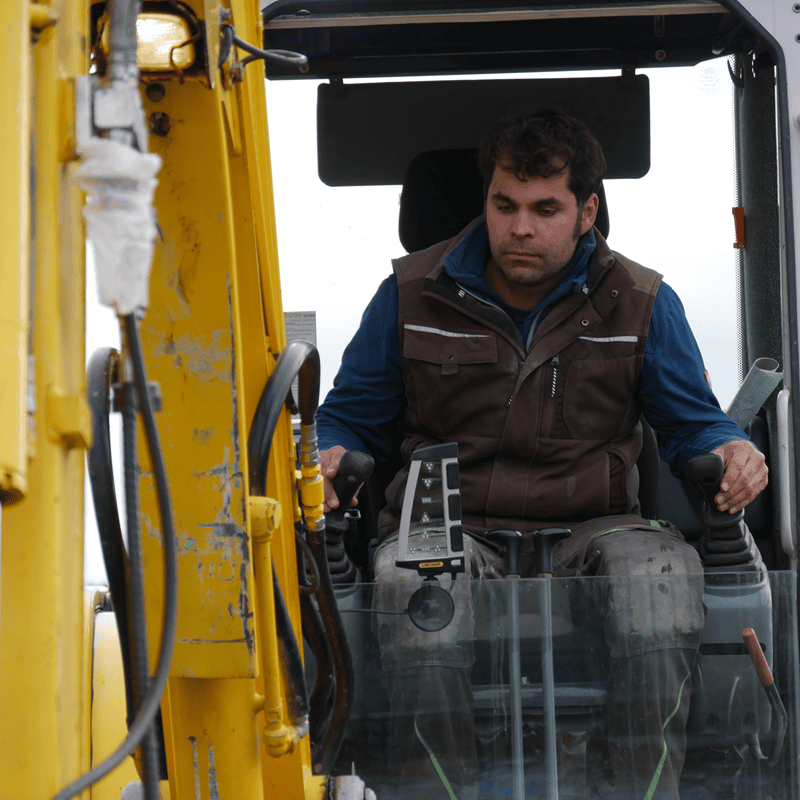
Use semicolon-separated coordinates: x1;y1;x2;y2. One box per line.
0;0;89;800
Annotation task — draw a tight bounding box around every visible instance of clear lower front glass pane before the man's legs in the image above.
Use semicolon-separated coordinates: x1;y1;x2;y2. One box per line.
322;572;798;800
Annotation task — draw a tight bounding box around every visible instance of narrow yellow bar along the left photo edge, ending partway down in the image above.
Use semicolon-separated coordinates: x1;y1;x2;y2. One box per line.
0;0;31;503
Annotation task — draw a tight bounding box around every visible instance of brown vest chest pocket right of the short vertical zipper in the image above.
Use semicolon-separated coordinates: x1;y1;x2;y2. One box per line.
564;356;637;441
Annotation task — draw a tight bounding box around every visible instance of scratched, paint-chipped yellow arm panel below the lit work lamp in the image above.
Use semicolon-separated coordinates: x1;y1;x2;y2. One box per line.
140;75;261;678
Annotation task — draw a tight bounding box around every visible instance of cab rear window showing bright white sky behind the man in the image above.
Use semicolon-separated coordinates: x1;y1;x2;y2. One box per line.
267;59;740;408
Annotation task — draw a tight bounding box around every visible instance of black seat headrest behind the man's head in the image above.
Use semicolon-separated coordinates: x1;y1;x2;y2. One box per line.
399;149;609;253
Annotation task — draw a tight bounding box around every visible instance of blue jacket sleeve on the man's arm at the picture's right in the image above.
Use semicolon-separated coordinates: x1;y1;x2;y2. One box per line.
638;283;747;475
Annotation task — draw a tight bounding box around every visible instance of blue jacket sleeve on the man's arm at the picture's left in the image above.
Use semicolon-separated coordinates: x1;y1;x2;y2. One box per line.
317;275;405;460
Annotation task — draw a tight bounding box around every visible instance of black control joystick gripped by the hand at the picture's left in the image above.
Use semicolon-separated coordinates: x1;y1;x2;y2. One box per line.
325;450;375;584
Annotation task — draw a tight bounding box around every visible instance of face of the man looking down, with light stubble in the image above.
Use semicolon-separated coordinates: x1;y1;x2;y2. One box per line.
486;163;598;308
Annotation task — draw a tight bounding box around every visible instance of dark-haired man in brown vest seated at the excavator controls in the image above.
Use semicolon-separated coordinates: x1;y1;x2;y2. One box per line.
318;110;767;800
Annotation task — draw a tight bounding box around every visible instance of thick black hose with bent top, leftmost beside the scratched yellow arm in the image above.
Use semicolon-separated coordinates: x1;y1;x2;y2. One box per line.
86;347;136;725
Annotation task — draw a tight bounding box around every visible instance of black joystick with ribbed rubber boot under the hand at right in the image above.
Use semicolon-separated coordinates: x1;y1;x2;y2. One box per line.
686;453;764;572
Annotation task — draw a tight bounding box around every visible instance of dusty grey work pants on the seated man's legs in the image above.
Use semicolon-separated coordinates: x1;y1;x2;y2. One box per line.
374;516;705;800
